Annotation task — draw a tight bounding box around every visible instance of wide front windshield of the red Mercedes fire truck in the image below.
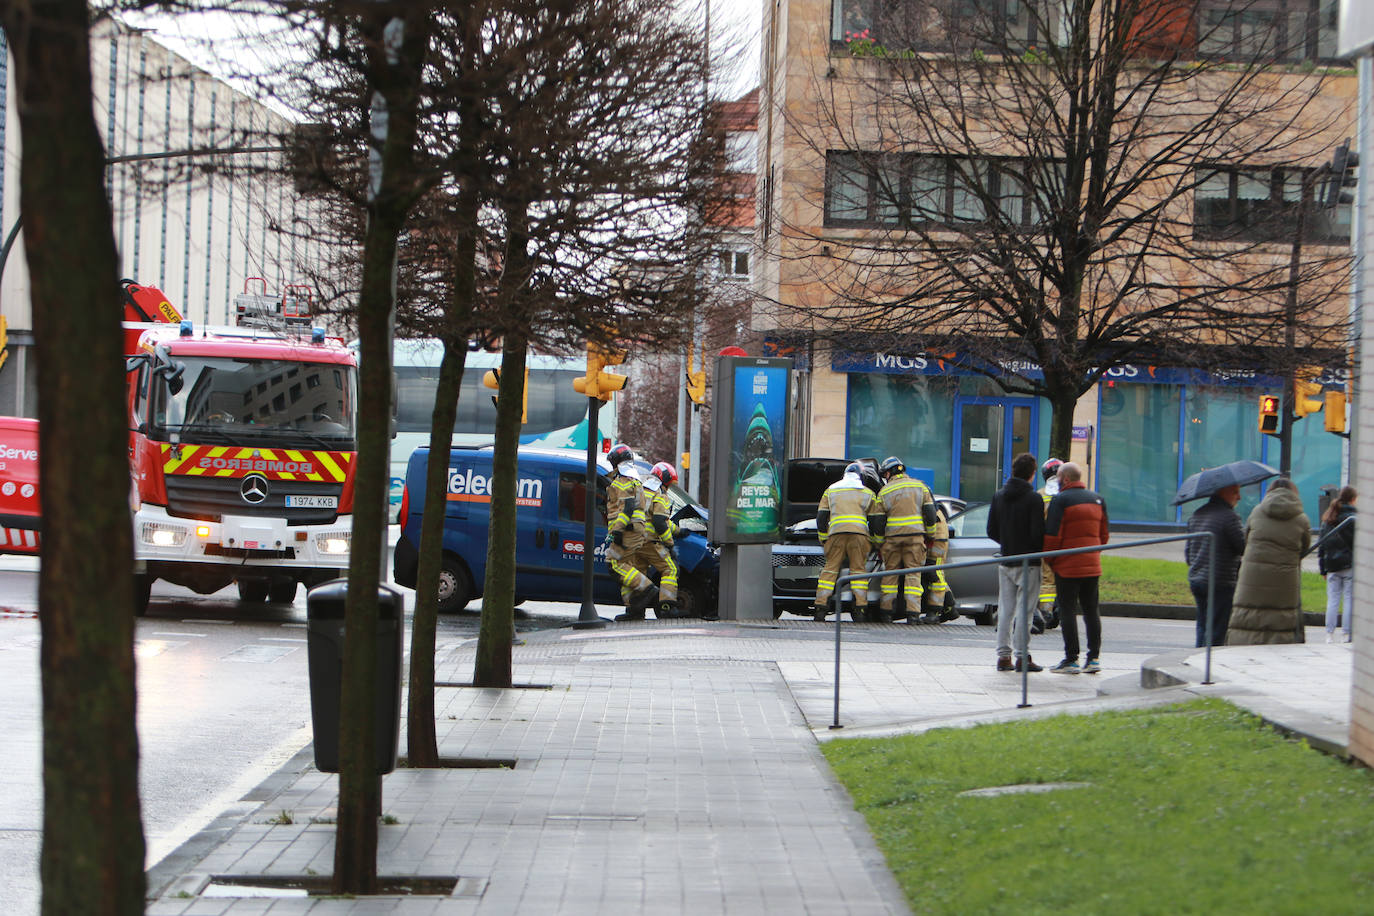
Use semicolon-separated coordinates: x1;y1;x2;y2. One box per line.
148;356;356;450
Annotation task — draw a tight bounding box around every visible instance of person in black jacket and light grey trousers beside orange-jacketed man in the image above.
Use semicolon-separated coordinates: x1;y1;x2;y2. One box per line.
988;452;1044;672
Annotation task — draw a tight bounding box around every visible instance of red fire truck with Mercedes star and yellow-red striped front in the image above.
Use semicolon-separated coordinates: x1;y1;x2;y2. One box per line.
124;287;357;611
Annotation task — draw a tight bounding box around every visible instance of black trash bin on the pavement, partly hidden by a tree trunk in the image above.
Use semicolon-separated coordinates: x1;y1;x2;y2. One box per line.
305;580;405;776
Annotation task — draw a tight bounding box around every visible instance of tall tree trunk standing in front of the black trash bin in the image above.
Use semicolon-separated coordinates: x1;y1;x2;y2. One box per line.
333;10;430;894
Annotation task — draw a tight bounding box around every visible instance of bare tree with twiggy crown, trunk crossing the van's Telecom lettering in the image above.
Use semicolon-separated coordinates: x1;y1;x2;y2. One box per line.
412;0;720;687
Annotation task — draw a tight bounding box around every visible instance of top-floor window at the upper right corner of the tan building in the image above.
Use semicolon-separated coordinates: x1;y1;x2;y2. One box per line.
1197;0;1340;62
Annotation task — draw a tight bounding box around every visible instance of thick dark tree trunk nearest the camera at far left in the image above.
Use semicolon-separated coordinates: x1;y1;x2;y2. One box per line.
0;0;146;916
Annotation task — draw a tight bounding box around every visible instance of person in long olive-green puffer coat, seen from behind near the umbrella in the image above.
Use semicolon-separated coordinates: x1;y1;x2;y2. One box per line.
1226;477;1312;645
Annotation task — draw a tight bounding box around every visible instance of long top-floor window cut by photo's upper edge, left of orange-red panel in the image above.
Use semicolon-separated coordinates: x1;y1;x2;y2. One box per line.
830;0;1070;51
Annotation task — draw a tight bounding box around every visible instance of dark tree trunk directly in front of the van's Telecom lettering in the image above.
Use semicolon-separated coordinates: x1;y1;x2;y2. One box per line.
473;334;526;687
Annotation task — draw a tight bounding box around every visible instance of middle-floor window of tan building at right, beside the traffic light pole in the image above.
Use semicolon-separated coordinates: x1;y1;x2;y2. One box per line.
1193;169;1351;242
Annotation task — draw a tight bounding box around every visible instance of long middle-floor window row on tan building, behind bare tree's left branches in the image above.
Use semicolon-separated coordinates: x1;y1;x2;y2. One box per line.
824;151;1046;227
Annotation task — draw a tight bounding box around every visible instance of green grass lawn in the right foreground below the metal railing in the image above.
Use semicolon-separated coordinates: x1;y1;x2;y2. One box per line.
824;699;1374;916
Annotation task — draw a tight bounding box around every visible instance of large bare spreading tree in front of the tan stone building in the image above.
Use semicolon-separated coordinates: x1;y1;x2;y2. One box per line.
779;0;1351;455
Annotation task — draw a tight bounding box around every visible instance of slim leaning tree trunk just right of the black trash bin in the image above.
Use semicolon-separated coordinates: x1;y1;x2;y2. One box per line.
401;338;467;766
